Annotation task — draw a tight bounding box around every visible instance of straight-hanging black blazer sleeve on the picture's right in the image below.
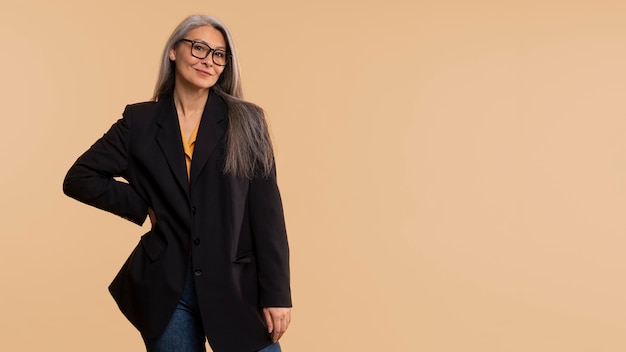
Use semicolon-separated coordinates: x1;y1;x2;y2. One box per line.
248;166;291;307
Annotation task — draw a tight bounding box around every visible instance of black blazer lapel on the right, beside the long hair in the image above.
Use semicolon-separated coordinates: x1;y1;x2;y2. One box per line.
190;90;228;184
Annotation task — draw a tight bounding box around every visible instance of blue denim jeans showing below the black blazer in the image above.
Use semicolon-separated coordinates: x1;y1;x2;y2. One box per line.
144;271;281;352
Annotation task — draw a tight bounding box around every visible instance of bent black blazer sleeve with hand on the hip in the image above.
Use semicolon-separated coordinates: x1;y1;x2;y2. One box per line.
63;107;148;225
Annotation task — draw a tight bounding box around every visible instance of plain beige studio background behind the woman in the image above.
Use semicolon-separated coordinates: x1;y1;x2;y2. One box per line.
0;0;626;352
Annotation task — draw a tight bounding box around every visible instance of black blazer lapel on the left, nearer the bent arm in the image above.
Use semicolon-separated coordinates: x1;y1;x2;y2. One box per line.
156;98;189;195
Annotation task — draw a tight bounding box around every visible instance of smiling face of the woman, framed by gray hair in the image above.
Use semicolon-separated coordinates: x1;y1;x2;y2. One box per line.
169;26;226;90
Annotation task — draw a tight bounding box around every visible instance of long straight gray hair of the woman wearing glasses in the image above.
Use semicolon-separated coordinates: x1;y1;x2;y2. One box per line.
152;15;274;179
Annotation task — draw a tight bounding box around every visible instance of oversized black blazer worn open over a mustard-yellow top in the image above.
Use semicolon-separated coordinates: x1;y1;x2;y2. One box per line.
63;91;291;352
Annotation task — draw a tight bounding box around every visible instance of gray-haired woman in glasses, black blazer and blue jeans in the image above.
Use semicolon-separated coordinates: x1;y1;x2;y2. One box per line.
63;15;291;352
